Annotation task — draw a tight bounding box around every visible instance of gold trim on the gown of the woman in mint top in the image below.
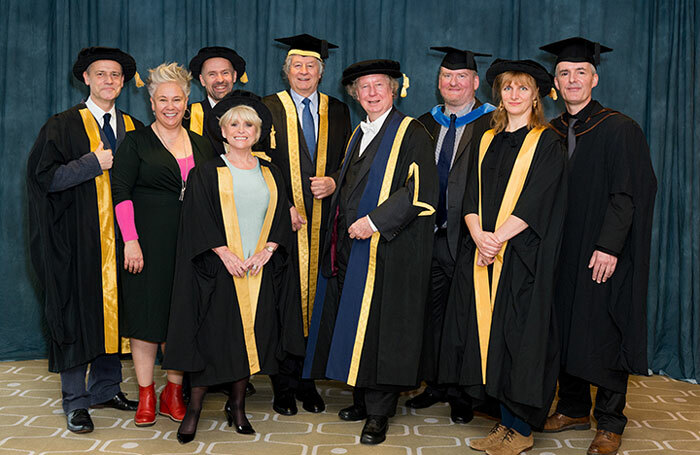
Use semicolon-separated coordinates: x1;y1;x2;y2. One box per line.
217;166;277;374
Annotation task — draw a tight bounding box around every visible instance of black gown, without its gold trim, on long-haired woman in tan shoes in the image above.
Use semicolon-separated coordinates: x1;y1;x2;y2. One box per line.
439;127;566;427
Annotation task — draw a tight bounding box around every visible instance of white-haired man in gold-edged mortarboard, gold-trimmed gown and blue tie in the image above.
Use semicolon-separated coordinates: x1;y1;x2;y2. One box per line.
263;34;350;415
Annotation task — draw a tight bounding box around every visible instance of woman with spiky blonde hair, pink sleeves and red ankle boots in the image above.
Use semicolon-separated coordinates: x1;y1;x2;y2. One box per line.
112;63;213;426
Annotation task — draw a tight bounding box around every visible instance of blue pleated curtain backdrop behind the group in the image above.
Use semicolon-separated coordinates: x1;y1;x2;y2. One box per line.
0;0;700;380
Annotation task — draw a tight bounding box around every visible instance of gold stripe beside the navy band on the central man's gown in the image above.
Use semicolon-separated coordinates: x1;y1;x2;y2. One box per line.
347;116;417;386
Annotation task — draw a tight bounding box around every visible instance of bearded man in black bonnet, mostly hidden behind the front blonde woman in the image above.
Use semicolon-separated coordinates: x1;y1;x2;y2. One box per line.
182;46;248;155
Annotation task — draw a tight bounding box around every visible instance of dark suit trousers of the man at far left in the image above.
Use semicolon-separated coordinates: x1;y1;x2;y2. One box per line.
61;354;122;414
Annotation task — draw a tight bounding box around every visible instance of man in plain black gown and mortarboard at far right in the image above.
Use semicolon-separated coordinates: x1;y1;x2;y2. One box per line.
542;38;656;454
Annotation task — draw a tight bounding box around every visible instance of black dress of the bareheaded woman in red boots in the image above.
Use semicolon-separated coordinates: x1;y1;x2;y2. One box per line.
112;128;213;342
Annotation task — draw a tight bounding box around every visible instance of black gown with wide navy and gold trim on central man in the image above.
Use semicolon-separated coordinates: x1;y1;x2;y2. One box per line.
304;108;438;391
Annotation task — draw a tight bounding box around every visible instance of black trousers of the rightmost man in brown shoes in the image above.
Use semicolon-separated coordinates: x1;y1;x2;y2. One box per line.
557;370;627;434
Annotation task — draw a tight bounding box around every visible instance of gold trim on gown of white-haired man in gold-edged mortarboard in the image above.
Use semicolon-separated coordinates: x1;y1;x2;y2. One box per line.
277;91;328;337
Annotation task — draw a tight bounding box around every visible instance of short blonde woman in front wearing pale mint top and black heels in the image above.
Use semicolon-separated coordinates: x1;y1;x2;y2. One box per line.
163;90;304;443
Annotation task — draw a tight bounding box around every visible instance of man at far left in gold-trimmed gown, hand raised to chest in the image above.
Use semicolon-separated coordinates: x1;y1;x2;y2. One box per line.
27;47;143;433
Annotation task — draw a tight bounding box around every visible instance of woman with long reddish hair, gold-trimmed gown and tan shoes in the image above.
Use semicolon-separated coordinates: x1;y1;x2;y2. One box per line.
440;60;566;455
